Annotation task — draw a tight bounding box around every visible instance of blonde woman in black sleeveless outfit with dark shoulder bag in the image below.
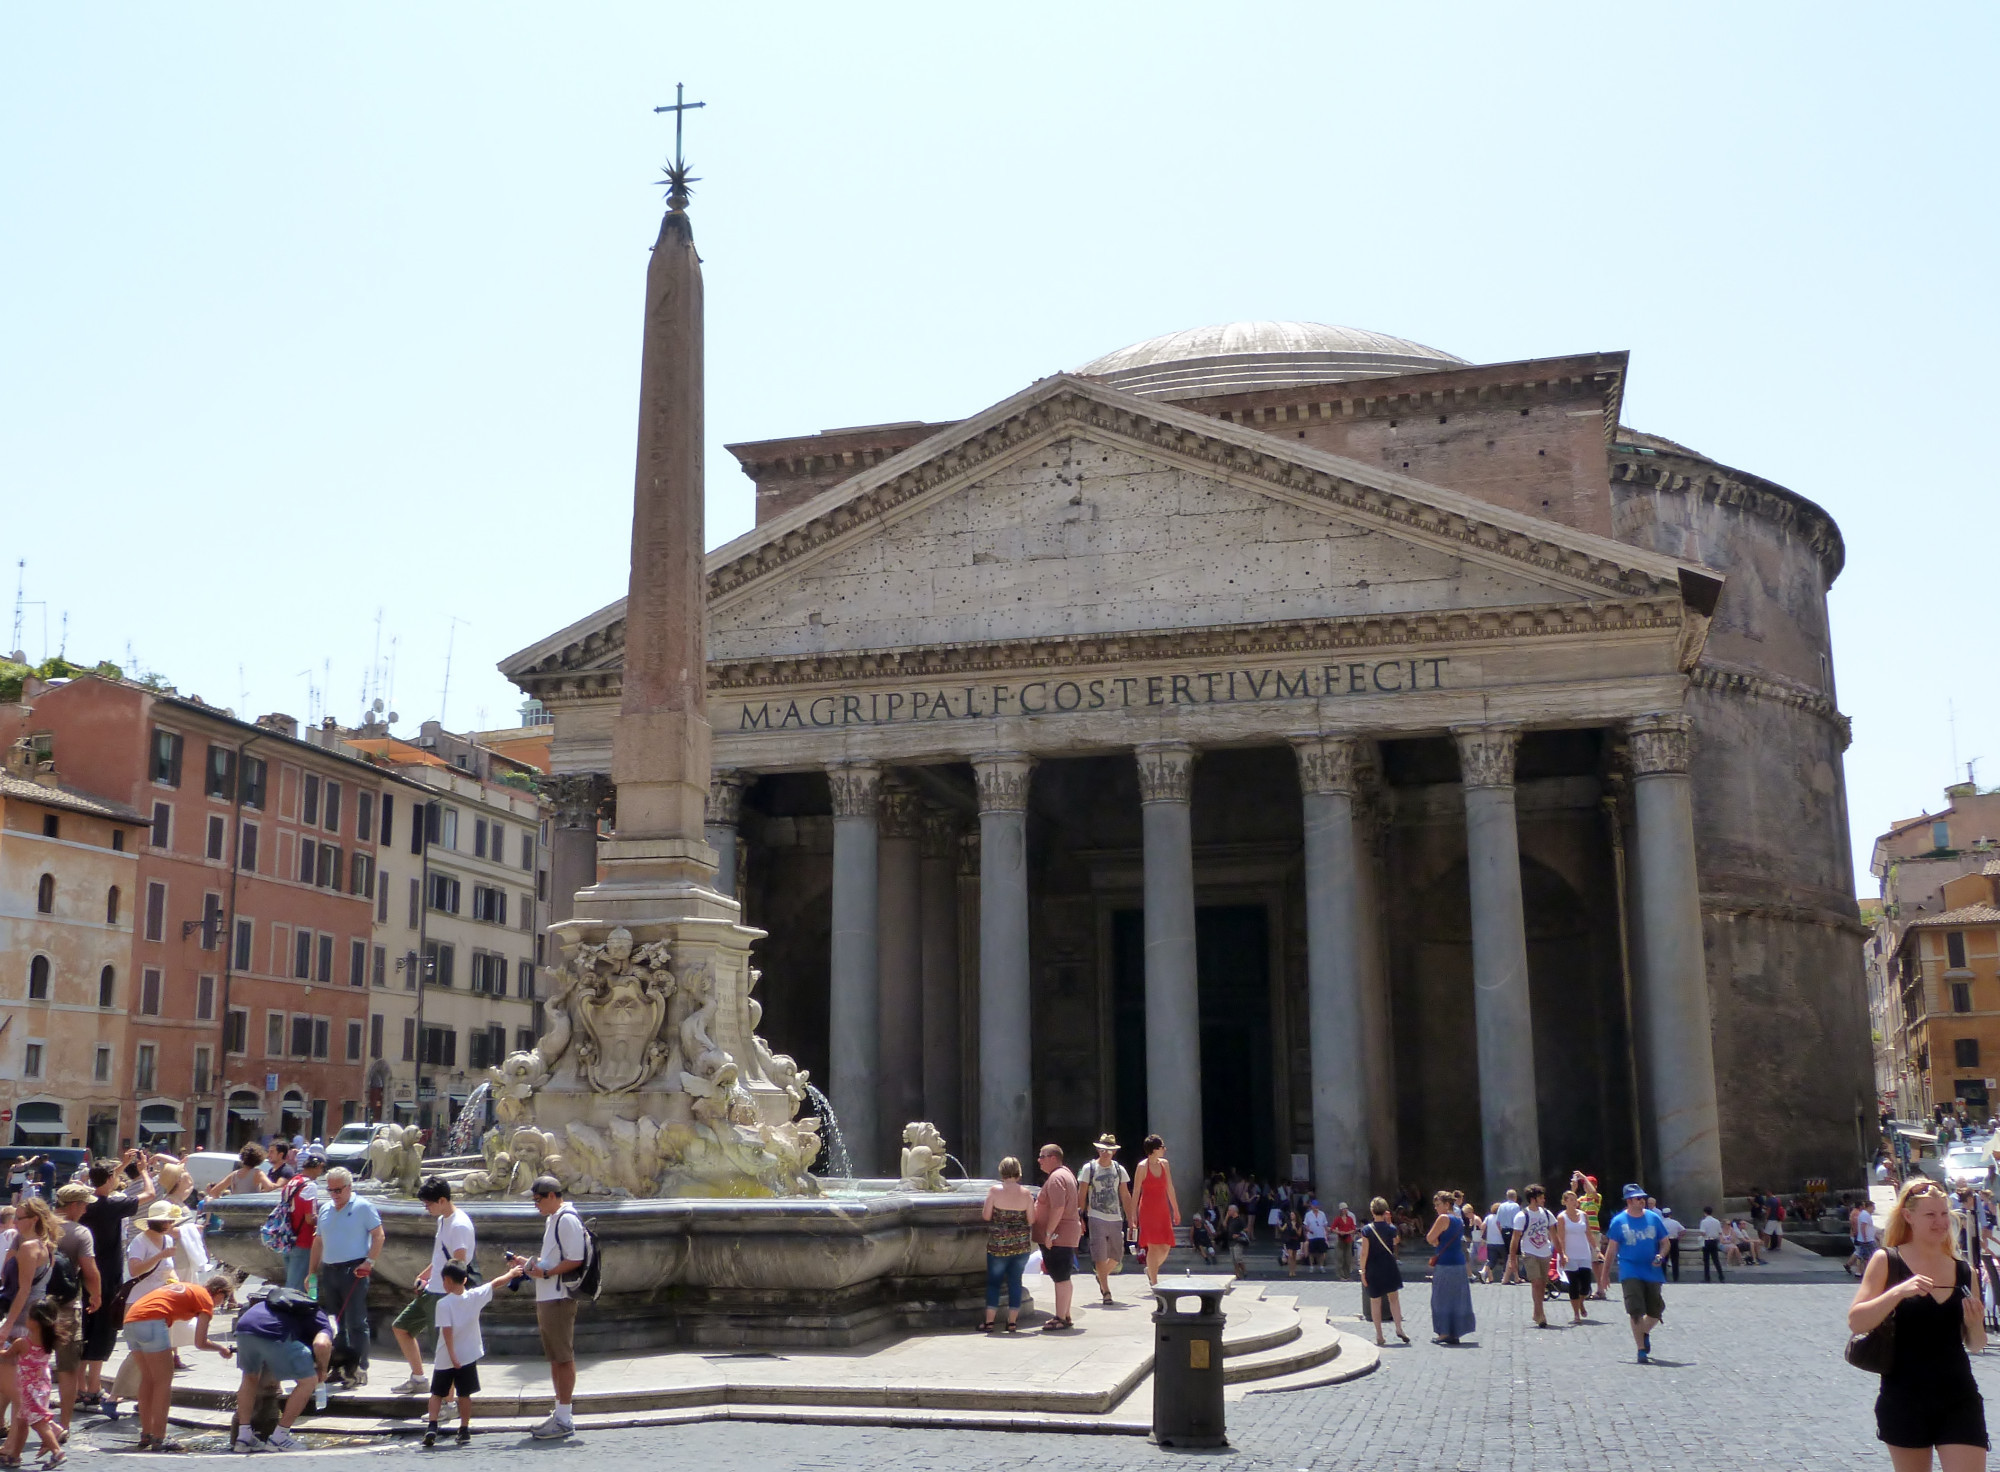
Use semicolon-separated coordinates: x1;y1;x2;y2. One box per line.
1848;1176;1986;1472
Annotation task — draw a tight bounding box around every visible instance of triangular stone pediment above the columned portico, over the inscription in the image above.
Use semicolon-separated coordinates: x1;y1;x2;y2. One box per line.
502;374;1720;678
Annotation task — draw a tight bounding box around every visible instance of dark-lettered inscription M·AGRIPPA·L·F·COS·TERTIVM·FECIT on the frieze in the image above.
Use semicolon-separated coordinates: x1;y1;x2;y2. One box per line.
722;656;1450;730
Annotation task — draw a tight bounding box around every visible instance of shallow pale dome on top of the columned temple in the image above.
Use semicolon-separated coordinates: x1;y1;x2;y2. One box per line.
1076;322;1466;398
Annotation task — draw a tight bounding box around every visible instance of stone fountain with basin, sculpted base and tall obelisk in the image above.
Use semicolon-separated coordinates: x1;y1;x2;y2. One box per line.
214;132;986;1354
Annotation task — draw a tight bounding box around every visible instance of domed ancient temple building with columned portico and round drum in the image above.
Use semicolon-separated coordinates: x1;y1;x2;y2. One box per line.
502;322;1872;1214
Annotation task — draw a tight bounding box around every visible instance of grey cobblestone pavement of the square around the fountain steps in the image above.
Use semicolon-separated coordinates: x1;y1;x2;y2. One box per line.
141;1280;2000;1472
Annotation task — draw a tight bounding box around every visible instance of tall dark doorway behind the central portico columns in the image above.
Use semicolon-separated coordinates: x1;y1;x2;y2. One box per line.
1112;904;1278;1176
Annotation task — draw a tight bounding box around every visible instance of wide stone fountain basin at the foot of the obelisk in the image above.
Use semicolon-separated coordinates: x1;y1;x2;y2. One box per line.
208;1180;988;1354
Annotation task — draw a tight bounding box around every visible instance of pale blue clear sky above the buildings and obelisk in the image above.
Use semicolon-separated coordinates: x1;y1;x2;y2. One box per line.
0;2;2000;892
